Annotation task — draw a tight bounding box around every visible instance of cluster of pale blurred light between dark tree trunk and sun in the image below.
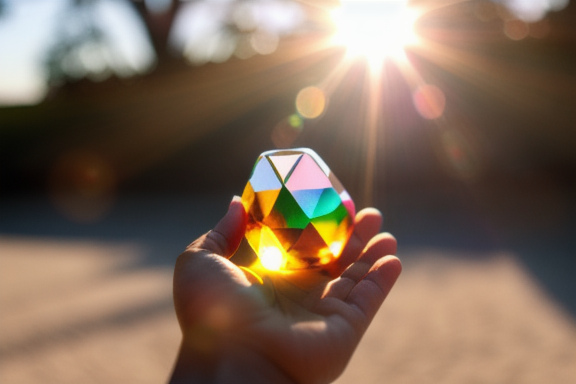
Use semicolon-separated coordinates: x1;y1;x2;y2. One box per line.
170;0;304;65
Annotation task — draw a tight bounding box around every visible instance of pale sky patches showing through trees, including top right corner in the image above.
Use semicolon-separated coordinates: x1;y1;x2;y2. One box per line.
0;0;568;106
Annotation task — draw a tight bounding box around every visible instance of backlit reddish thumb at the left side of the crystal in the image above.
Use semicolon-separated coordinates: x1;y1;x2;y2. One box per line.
188;196;247;257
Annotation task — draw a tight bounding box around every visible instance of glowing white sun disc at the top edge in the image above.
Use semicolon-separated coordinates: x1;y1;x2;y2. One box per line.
331;0;417;66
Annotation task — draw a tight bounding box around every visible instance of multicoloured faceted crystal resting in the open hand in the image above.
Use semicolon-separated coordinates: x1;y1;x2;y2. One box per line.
242;148;356;271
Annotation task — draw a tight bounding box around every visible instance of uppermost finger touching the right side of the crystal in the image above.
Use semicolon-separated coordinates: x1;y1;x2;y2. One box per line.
330;208;382;277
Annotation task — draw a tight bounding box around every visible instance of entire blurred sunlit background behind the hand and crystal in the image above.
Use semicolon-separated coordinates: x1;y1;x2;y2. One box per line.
0;0;576;383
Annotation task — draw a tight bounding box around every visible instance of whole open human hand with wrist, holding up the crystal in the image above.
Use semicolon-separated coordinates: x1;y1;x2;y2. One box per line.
170;198;402;384
